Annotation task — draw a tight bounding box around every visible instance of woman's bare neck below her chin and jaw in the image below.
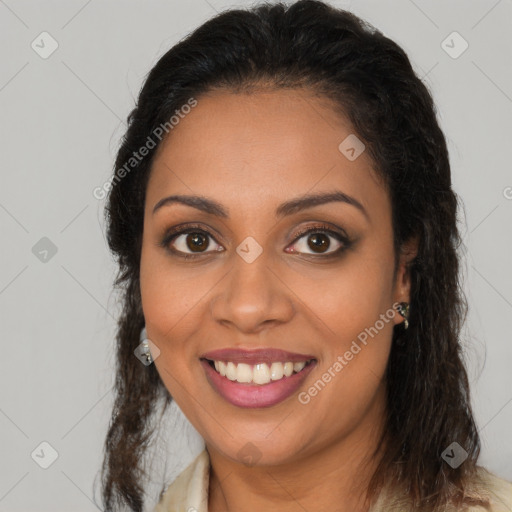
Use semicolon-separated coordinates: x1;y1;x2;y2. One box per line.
207;384;384;512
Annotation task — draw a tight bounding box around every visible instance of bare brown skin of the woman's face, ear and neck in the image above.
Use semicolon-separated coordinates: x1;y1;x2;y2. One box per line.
140;89;417;512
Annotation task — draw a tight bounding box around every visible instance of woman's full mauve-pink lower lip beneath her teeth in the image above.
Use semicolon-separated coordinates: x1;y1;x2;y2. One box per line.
201;359;316;408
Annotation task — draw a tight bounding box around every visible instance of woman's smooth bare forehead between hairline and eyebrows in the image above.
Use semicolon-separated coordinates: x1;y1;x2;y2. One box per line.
147;89;389;220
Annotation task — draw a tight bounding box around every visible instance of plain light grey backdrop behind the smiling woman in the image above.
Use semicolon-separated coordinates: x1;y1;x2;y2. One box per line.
0;0;512;512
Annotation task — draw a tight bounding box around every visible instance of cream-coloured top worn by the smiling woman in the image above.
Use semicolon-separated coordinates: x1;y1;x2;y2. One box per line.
153;450;512;512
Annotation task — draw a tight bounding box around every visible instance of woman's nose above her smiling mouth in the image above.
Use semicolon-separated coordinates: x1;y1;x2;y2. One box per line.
210;253;295;334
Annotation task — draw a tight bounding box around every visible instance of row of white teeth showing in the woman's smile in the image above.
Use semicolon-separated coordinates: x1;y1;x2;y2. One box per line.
209;361;312;384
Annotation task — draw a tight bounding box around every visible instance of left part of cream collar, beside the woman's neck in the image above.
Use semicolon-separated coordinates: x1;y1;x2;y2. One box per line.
152;450;210;512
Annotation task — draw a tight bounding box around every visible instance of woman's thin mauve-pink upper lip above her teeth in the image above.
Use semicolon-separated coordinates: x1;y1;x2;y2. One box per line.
200;348;315;364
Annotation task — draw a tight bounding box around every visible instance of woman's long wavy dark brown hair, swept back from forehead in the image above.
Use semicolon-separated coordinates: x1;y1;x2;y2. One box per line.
97;0;480;512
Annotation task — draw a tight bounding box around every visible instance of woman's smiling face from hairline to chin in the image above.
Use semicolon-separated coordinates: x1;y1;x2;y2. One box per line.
140;90;416;464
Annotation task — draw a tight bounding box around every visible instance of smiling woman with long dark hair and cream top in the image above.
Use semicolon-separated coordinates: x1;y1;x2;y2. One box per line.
102;0;512;512
